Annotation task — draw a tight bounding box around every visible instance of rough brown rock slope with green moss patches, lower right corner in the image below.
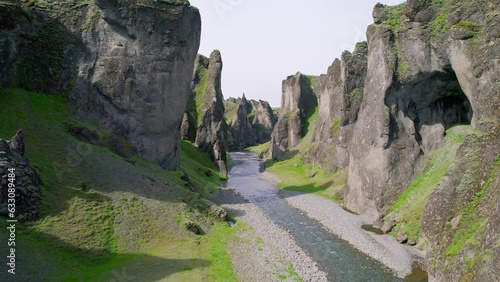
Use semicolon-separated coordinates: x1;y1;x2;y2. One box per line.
422;127;500;281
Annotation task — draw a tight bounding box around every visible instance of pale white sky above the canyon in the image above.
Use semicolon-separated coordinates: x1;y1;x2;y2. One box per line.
190;0;404;107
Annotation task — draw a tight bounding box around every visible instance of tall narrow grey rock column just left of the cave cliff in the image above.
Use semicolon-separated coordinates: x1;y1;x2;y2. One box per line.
309;42;368;171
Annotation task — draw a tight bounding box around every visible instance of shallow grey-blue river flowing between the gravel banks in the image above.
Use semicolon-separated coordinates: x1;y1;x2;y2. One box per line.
226;153;425;282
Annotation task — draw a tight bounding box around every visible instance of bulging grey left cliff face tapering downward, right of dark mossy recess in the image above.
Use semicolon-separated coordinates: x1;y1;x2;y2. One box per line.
71;0;201;169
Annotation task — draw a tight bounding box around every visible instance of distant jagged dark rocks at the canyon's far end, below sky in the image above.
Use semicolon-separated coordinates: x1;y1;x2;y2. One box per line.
225;94;277;151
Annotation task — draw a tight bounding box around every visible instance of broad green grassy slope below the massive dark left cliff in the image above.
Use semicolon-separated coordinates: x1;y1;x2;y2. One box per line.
0;89;241;281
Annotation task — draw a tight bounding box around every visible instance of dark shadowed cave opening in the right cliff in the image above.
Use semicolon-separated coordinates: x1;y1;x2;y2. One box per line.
386;66;473;154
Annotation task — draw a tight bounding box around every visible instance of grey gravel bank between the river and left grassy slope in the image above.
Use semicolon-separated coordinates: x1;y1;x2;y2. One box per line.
216;188;327;282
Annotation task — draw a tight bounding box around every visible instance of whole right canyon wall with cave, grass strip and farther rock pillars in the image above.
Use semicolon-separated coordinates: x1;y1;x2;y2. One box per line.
271;0;500;281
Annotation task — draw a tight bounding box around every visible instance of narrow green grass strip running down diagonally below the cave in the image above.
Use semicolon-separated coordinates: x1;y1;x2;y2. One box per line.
388;126;470;240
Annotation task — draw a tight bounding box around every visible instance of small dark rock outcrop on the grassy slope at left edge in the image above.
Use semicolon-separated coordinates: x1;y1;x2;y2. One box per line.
0;130;41;221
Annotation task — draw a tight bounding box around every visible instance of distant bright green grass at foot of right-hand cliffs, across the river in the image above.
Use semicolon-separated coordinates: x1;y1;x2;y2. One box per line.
252;108;347;202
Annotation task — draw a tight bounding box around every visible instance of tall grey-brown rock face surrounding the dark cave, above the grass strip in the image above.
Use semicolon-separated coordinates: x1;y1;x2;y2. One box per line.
345;1;500;217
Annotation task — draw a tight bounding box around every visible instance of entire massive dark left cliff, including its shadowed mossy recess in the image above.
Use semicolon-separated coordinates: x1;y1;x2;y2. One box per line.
0;0;201;169
